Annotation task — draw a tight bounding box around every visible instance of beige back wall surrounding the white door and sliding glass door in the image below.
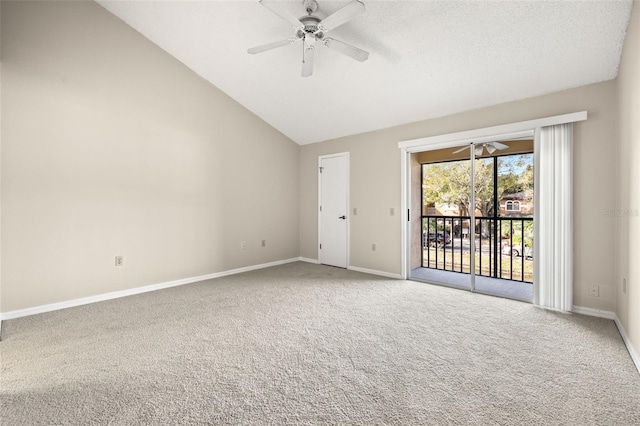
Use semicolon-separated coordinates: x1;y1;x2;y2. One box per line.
300;81;617;311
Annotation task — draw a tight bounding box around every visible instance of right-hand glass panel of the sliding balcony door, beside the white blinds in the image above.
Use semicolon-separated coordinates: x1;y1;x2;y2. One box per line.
474;145;534;302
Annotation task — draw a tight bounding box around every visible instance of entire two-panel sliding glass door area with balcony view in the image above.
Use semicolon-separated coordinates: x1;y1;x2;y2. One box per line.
411;140;534;302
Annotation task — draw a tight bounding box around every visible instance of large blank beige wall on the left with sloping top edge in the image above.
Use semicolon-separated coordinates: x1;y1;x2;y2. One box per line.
1;1;299;312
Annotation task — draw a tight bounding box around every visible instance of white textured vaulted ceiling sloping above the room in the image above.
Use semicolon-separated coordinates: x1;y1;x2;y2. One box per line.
98;0;632;144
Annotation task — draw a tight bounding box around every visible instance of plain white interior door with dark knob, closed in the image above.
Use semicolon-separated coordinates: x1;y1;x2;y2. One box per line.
318;153;349;268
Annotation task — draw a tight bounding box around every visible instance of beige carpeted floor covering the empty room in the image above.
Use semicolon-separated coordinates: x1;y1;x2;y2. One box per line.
0;263;640;426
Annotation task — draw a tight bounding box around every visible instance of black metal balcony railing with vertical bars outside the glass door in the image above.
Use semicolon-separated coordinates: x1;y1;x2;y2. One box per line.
422;216;535;283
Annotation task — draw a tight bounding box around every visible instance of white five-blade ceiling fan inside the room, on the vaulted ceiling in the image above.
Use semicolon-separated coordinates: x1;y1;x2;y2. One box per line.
247;0;369;77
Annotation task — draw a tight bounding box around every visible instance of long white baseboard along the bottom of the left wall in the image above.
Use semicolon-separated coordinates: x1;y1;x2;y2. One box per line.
0;257;300;321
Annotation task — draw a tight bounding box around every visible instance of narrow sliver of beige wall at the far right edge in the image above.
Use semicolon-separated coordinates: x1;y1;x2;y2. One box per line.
612;1;640;362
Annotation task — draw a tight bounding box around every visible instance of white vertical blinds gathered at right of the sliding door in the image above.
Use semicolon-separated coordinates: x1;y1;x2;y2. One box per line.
533;123;573;312
